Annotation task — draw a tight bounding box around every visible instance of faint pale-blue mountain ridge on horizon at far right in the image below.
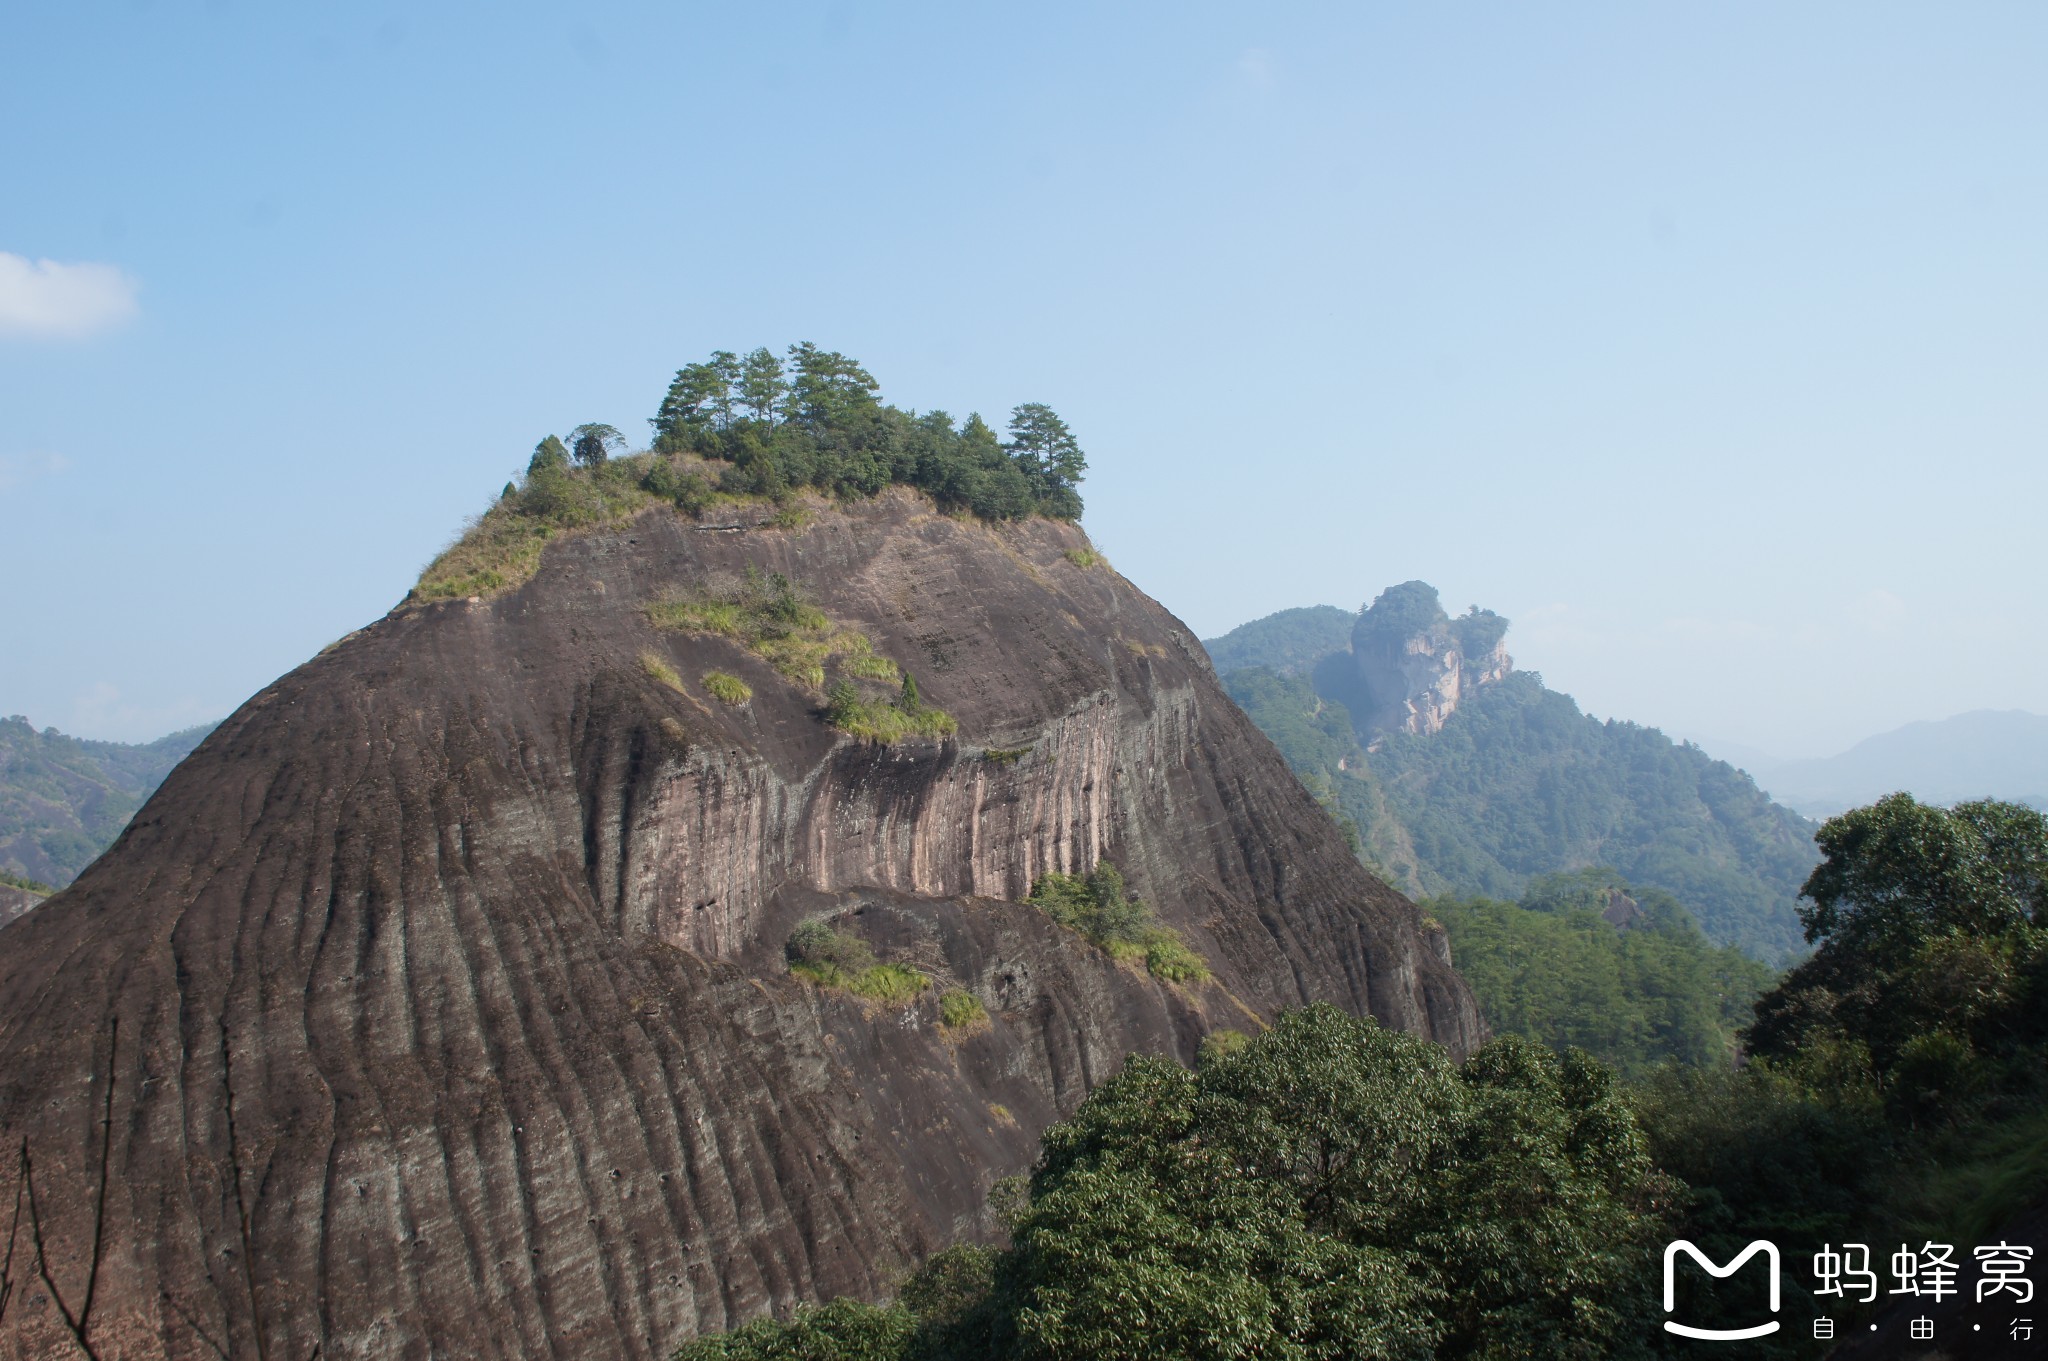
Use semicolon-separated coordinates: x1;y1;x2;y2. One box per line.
1741;708;2048;817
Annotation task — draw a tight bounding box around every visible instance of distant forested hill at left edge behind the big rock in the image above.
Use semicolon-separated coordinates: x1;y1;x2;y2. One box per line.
0;714;213;888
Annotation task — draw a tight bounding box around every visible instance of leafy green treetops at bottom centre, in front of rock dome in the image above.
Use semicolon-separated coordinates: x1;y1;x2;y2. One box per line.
676;1005;1671;1361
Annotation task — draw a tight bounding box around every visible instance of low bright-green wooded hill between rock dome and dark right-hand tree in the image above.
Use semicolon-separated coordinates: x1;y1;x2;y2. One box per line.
1423;870;1774;1077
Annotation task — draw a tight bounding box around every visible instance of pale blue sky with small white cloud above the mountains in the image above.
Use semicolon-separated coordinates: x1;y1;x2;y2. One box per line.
0;0;2048;755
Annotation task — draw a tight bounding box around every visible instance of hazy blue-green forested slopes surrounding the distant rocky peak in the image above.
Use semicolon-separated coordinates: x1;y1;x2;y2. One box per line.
1206;591;1815;962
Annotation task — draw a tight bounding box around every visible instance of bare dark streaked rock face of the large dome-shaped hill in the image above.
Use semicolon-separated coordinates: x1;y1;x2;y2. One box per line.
0;491;1483;1361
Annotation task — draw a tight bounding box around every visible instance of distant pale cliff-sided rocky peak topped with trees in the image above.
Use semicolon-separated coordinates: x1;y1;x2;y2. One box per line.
1352;581;1516;733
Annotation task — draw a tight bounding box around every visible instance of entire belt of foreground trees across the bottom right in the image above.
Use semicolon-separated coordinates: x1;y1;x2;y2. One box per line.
676;794;2048;1361
